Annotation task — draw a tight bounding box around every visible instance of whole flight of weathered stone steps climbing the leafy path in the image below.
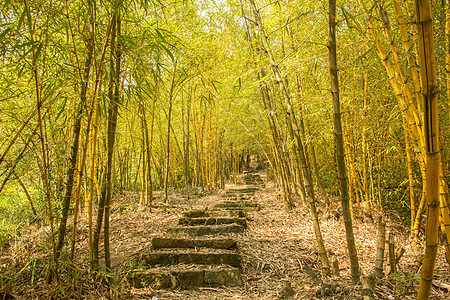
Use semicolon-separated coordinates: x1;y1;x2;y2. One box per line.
128;173;264;290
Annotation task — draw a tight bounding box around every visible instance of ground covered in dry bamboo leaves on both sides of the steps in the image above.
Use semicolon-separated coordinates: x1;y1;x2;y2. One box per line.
0;172;450;300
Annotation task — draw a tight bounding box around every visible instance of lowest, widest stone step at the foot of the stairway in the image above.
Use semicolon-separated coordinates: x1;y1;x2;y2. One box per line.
127;266;242;290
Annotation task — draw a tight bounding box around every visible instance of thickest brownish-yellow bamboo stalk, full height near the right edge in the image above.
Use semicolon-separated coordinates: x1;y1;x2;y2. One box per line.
415;0;440;300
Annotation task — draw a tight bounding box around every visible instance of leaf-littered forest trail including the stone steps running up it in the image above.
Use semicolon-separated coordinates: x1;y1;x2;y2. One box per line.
2;172;449;300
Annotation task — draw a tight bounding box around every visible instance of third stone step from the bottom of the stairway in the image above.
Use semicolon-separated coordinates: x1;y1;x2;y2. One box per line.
152;238;237;249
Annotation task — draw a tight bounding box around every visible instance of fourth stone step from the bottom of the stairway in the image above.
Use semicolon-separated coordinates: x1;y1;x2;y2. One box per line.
167;224;245;236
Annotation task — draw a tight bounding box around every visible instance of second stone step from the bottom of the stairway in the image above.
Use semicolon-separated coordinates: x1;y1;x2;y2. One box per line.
140;250;241;268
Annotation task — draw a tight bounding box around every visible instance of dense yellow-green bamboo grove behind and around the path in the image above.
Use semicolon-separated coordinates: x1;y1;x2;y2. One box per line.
0;0;450;292
